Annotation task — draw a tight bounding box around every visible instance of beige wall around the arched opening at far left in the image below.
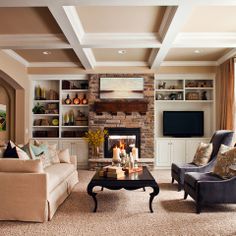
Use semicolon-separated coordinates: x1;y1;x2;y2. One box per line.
0;51;29;143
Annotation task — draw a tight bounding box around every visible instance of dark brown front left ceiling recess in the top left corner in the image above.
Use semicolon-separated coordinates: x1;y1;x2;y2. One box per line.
0;7;62;34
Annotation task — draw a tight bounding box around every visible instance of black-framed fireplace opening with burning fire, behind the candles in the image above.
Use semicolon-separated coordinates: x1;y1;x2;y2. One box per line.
104;128;140;158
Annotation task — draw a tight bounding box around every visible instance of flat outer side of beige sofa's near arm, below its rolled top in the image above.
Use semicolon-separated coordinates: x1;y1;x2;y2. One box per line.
0;172;48;222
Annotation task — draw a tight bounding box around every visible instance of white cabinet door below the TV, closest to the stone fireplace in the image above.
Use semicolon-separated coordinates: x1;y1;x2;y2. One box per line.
156;140;171;167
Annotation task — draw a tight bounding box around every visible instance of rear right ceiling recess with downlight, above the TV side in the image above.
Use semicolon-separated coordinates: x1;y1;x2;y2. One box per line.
165;48;229;61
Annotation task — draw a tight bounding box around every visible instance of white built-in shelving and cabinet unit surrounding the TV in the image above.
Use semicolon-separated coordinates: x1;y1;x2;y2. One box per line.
155;74;215;169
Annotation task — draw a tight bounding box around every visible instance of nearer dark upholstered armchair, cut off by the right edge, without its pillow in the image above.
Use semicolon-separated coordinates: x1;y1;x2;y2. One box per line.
184;172;236;213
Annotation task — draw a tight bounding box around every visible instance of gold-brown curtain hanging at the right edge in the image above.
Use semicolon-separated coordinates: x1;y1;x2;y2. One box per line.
216;58;234;130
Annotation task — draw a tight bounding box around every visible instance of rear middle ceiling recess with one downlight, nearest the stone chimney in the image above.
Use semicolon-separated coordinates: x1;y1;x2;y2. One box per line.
93;48;151;62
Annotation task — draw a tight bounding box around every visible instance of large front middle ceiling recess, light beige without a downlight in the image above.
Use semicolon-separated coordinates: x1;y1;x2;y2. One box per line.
77;6;166;33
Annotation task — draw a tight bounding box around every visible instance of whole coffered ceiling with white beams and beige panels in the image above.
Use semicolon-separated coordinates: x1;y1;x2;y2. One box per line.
0;0;236;71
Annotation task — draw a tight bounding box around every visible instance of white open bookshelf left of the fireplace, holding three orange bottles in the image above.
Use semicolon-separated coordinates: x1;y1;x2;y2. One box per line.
31;76;89;139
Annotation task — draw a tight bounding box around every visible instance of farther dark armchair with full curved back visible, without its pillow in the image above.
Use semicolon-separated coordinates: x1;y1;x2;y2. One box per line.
171;130;234;191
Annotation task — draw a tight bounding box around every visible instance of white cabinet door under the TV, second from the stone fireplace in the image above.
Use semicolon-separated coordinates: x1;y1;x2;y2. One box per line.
171;140;185;164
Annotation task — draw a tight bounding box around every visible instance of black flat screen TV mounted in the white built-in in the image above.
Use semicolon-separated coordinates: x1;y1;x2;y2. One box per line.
163;111;204;137
